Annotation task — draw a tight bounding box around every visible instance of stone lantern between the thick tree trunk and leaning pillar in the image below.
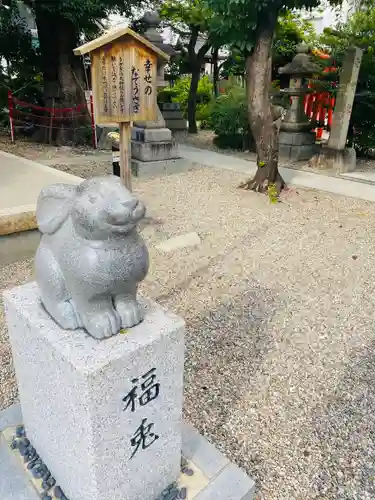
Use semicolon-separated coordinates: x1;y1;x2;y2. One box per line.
279;44;320;161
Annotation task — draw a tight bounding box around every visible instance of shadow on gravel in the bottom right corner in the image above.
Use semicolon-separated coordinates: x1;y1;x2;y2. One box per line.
312;343;375;500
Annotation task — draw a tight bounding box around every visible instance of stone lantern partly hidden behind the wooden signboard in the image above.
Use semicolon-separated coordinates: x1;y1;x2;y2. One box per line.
132;12;189;176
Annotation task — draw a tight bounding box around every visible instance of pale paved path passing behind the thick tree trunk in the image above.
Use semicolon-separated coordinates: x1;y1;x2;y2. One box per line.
178;144;375;201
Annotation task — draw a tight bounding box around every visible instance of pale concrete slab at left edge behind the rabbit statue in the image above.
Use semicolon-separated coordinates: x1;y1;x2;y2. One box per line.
0;151;82;235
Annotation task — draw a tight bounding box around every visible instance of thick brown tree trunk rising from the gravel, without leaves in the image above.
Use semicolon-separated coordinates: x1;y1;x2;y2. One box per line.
241;11;284;193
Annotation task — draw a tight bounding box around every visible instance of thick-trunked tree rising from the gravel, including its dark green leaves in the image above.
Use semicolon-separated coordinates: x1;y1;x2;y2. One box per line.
208;0;338;192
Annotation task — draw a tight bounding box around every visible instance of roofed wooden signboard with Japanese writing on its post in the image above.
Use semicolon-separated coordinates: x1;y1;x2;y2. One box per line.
74;28;169;191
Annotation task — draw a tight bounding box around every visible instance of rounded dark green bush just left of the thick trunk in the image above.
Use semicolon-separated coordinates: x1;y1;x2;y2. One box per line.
209;87;253;150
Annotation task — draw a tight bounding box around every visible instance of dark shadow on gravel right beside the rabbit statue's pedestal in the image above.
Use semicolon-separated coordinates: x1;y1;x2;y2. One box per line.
184;280;284;481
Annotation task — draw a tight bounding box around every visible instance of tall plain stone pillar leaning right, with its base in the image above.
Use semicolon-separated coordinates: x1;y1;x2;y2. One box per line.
310;47;363;173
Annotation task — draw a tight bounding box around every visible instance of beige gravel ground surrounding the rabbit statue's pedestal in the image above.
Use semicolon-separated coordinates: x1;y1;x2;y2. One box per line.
0;169;375;500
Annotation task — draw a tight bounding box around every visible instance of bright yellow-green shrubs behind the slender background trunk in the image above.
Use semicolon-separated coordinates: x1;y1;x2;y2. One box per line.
158;75;213;116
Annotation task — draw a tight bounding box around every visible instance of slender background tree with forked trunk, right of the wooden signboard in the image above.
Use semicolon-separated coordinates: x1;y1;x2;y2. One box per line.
160;0;217;134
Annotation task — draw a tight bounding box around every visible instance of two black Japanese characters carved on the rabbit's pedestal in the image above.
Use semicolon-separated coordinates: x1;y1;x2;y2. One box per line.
123;368;160;458
